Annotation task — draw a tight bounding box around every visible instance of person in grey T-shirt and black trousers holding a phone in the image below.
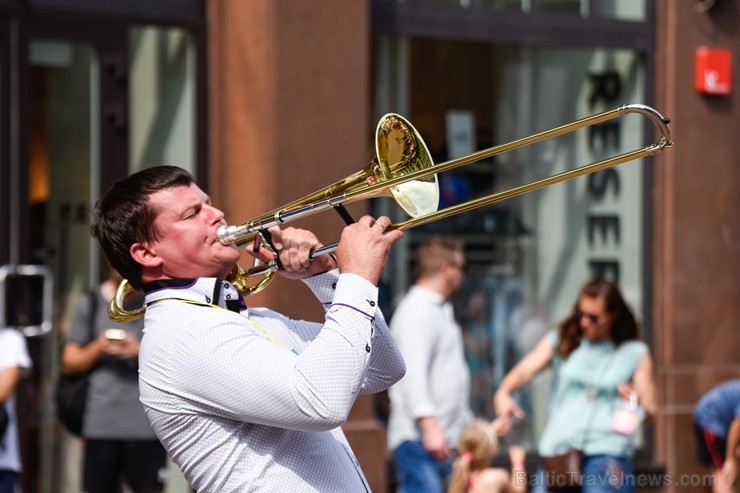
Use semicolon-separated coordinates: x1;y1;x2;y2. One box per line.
62;258;167;493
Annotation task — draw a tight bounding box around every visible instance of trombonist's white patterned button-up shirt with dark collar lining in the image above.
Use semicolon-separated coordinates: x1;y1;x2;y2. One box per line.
139;271;405;493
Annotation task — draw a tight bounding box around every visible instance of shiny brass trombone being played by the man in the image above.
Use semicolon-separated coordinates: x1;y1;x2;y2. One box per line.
108;104;673;322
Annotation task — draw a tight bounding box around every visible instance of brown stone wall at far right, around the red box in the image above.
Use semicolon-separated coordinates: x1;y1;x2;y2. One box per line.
652;0;740;491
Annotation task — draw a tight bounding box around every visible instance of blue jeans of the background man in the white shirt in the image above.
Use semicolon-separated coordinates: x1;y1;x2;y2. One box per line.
393;441;453;493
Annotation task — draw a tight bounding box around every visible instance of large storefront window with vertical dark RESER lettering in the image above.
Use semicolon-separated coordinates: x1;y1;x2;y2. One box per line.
374;37;646;446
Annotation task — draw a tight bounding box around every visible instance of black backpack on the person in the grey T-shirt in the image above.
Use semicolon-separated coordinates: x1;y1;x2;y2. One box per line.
54;290;98;436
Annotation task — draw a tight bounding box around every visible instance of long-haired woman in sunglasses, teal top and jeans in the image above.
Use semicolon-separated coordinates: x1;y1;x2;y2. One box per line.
493;279;657;493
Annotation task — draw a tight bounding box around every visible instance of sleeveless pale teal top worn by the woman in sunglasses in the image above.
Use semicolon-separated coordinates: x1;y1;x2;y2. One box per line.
539;331;648;458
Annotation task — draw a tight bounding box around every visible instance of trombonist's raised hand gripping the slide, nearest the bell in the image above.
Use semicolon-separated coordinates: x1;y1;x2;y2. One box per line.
336;216;403;285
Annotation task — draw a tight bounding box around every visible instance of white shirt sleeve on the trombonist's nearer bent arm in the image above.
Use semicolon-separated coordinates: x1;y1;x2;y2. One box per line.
163;274;402;431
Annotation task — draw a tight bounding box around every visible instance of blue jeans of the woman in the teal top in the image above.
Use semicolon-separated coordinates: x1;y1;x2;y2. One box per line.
532;455;635;493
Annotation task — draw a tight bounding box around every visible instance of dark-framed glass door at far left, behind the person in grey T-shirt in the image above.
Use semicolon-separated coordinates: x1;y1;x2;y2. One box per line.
11;21;127;493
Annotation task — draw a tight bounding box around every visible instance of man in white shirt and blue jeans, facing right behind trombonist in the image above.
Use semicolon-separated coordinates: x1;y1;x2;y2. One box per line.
388;236;472;493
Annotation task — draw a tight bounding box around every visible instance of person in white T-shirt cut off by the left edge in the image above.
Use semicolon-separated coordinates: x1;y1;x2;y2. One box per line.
0;327;31;493
